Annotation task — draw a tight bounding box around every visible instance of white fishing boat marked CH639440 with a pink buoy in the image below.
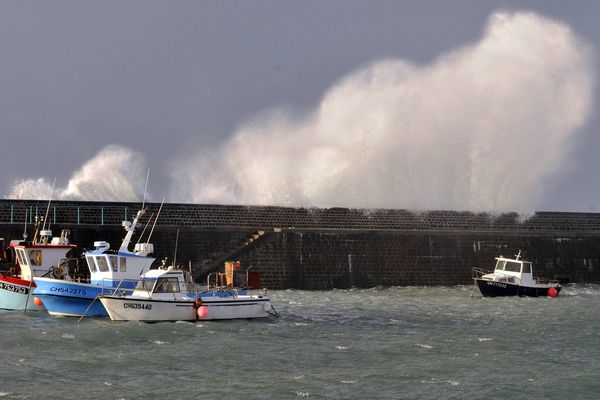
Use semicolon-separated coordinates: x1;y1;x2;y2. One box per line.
99;266;276;322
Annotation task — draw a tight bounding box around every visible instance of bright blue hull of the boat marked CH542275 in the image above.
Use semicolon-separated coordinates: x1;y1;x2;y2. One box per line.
33;278;132;318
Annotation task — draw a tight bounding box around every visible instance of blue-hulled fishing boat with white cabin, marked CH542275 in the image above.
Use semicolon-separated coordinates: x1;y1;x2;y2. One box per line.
33;205;162;317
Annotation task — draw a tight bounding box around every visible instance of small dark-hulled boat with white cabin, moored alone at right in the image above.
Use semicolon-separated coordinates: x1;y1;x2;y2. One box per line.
473;250;561;297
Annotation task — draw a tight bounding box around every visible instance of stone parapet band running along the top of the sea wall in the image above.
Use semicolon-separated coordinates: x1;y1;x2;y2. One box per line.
0;199;600;233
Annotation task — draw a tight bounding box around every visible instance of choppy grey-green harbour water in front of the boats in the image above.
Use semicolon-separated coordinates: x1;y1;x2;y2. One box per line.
0;285;600;400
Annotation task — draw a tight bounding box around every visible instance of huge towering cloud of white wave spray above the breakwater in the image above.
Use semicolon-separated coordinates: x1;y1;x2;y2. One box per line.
171;12;593;211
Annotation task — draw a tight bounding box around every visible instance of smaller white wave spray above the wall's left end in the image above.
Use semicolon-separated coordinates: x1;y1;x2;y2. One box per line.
9;145;146;202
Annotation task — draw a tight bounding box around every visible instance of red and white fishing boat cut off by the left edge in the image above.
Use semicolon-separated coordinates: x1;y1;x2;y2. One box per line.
0;220;81;311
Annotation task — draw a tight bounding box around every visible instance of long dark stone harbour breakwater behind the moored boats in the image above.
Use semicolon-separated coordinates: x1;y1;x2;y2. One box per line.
0;200;600;290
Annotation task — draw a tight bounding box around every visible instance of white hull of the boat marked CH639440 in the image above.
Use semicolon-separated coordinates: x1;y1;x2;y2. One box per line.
100;296;271;322
